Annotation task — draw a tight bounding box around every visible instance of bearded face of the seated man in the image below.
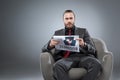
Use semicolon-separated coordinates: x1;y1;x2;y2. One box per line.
63;12;75;28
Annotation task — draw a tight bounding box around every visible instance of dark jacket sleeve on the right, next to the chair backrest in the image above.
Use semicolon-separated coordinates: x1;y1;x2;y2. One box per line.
82;29;97;57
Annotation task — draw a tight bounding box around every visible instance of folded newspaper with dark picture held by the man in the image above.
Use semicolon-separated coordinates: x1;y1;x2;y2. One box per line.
53;35;79;52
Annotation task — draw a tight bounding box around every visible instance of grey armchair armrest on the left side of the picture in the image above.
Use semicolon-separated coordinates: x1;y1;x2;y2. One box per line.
40;52;54;80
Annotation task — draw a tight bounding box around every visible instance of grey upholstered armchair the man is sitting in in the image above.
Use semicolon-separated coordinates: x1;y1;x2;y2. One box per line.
40;38;113;80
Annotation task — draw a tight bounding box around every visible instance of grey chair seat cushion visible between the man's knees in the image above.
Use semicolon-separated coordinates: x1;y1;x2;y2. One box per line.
69;68;87;79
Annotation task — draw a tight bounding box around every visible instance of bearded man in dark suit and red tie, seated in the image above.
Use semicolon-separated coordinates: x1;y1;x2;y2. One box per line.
42;10;101;80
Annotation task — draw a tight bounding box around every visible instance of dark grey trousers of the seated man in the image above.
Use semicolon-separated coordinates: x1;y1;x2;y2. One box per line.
53;56;102;80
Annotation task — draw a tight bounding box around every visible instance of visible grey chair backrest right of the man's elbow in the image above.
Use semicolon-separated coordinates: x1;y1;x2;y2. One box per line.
92;38;107;61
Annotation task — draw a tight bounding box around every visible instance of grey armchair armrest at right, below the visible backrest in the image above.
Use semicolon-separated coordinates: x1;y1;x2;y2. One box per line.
102;52;113;80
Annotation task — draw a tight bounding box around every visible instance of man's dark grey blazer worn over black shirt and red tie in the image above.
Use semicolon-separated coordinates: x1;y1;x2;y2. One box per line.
42;27;97;60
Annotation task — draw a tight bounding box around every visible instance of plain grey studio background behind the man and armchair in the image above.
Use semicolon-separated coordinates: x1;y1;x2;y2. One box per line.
0;0;120;80
